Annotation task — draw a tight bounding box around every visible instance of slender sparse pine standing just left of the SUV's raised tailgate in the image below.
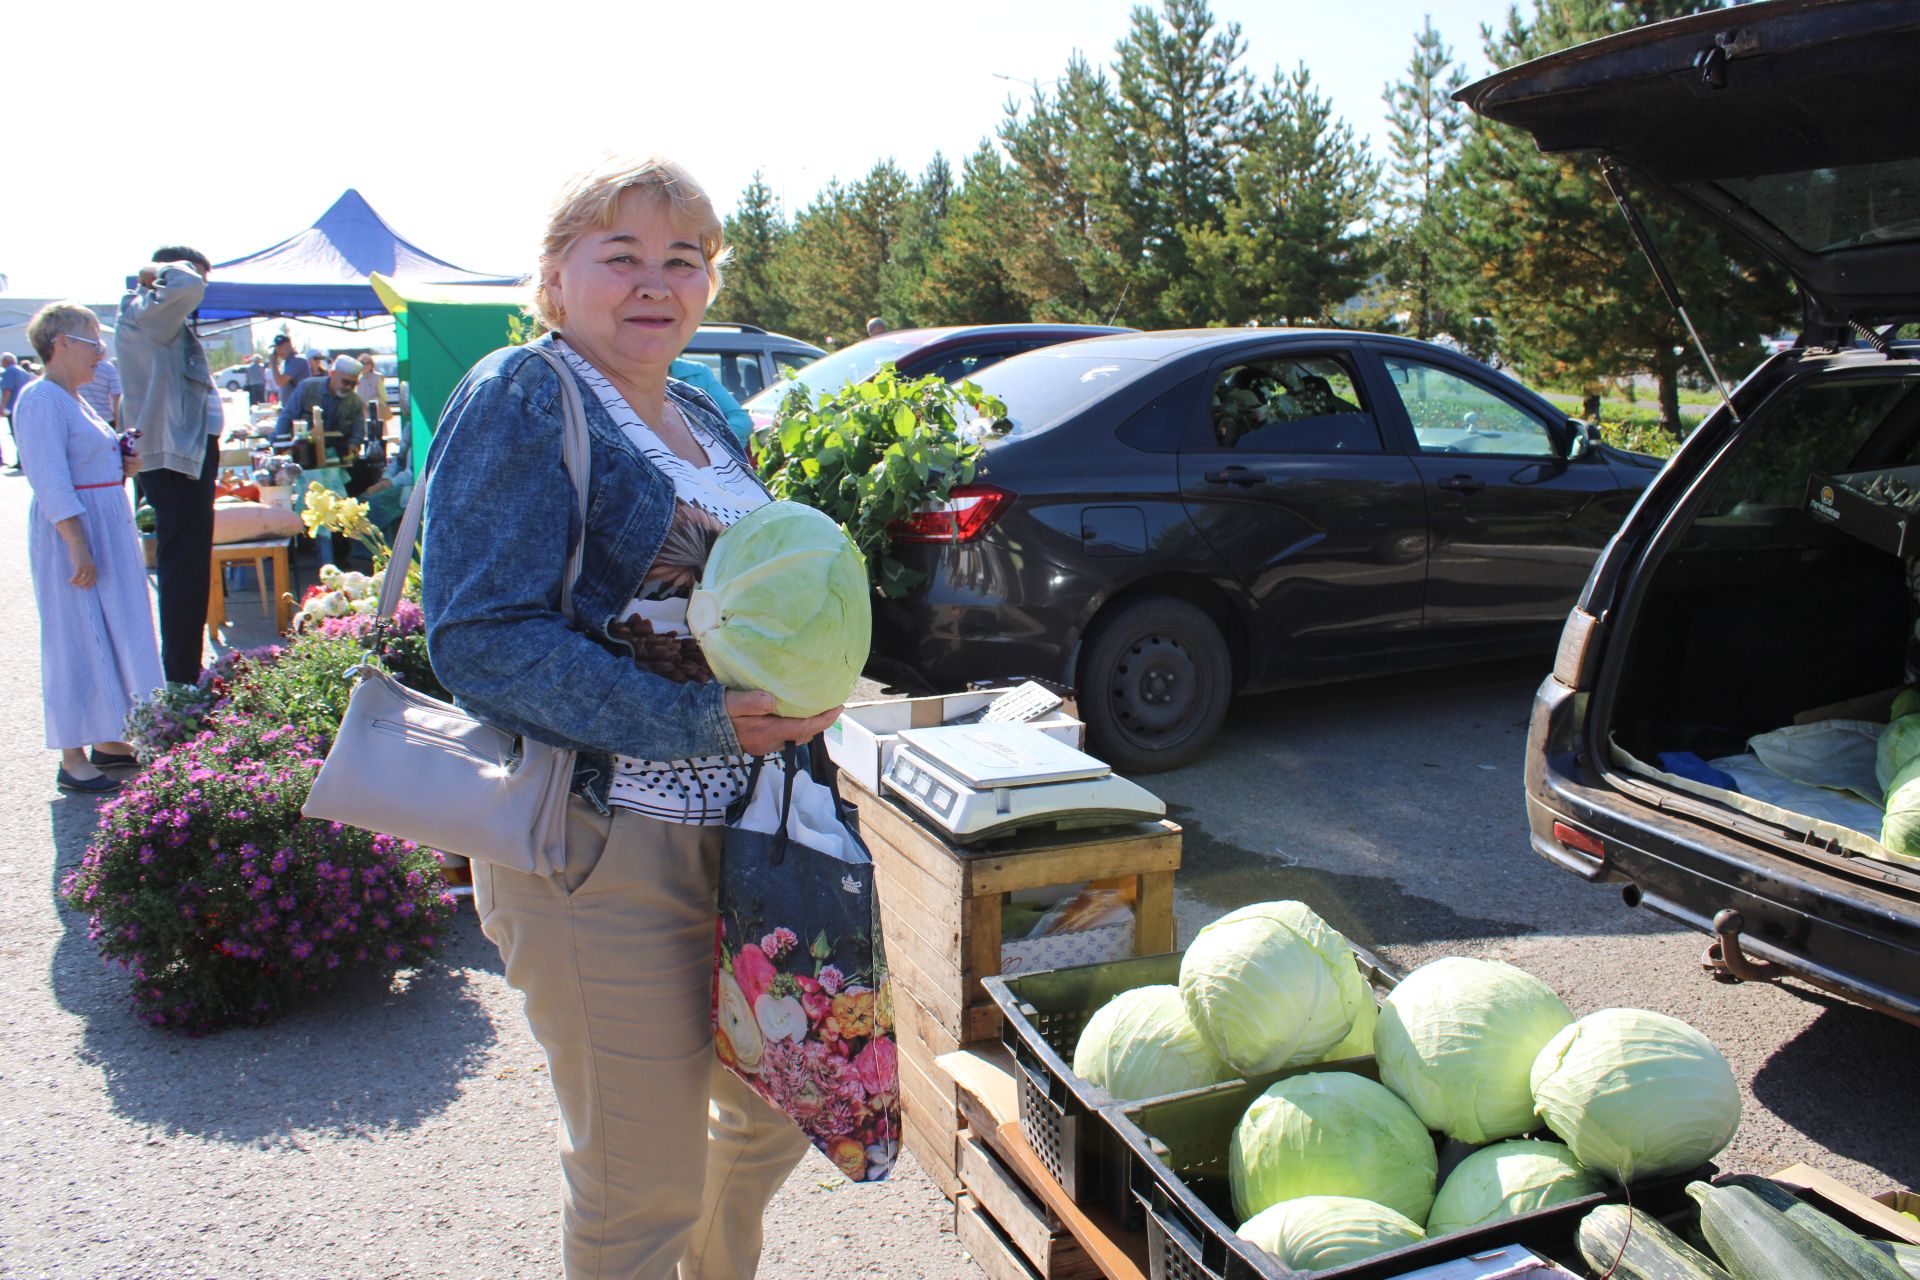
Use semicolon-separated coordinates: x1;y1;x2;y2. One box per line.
1380;17;1471;338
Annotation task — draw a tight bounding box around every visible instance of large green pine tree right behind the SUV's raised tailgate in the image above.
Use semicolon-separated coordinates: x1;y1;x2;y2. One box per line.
1457;0;1793;434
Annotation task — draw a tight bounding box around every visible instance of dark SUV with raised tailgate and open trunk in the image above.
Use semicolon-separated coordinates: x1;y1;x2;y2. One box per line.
1461;0;1920;1021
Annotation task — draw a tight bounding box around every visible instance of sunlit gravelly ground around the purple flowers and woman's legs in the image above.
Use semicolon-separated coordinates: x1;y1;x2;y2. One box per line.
0;476;979;1280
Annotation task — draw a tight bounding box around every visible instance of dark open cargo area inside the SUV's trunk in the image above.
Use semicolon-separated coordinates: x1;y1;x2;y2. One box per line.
1601;357;1920;885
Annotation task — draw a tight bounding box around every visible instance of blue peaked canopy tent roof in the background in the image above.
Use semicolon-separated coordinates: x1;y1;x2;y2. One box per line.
200;188;518;320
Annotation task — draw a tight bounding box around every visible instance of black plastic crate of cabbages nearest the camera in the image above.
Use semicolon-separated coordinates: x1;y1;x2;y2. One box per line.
1106;1057;1716;1280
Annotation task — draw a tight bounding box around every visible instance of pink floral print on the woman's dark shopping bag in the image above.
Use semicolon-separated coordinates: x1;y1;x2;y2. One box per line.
714;901;900;1182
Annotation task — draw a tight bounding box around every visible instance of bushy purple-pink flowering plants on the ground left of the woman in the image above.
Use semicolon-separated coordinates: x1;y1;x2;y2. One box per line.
61;633;453;1032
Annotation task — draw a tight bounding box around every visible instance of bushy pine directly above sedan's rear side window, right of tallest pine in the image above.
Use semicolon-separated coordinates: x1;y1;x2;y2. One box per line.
1187;65;1379;324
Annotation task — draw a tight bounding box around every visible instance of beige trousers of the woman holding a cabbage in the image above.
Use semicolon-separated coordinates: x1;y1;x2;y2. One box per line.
474;796;806;1280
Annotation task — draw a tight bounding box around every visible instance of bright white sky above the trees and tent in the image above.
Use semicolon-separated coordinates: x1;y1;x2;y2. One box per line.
0;0;1530;317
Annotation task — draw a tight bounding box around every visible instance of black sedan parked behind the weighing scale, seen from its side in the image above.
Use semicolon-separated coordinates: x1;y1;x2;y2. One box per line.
875;328;1659;773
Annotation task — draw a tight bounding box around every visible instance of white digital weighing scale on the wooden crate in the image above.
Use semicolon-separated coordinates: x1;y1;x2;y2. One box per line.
881;723;1167;844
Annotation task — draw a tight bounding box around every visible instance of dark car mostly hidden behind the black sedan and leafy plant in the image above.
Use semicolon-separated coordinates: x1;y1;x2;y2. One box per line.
743;324;1135;432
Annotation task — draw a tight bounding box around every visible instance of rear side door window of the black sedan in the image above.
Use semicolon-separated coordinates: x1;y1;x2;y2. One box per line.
1212;355;1380;453
